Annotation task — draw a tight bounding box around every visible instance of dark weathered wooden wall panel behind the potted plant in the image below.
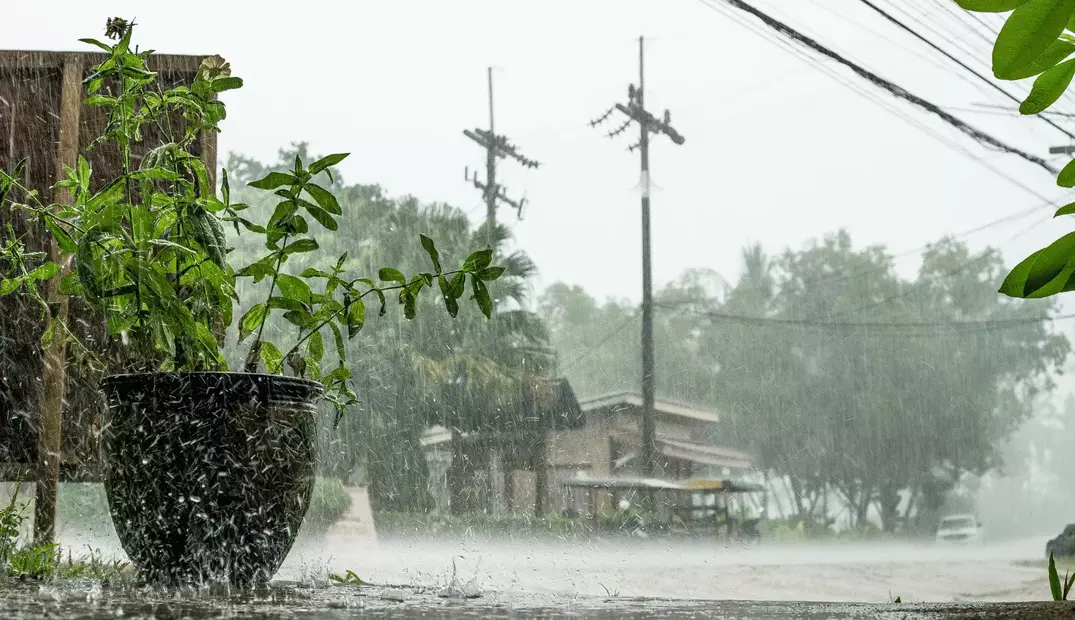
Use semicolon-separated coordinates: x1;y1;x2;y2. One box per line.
0;51;216;480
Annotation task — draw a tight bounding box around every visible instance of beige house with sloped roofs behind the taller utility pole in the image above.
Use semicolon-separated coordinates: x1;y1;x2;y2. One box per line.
421;380;753;515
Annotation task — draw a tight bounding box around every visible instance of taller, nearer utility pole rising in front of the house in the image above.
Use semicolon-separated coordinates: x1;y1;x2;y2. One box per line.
590;37;684;477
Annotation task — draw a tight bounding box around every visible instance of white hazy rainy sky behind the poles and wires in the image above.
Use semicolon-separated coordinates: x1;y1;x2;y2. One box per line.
0;0;1075;309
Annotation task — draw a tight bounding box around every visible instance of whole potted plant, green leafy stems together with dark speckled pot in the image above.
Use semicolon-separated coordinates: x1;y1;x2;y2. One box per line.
0;19;503;585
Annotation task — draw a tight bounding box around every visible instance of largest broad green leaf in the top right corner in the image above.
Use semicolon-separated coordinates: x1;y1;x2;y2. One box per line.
992;0;1075;80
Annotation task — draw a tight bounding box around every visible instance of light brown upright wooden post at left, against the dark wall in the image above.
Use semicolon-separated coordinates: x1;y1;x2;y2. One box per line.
33;55;84;544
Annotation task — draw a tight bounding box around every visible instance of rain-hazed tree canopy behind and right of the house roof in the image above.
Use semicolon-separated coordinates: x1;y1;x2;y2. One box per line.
541;231;1070;529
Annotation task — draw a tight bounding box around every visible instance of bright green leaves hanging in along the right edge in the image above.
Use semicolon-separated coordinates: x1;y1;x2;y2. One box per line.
956;0;1075;298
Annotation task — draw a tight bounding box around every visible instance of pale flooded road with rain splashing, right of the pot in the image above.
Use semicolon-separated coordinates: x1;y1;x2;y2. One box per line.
281;538;1049;603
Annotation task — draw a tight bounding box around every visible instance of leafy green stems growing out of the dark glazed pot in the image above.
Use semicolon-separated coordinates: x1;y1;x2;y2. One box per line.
0;23;504;421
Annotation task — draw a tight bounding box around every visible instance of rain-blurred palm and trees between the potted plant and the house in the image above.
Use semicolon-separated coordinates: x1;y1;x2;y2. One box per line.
222;144;556;511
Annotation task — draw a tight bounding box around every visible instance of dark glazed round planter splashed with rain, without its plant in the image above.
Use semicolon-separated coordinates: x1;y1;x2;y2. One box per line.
101;373;324;586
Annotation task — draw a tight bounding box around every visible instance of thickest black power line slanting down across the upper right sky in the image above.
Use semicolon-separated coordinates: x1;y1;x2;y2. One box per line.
700;0;1057;174
